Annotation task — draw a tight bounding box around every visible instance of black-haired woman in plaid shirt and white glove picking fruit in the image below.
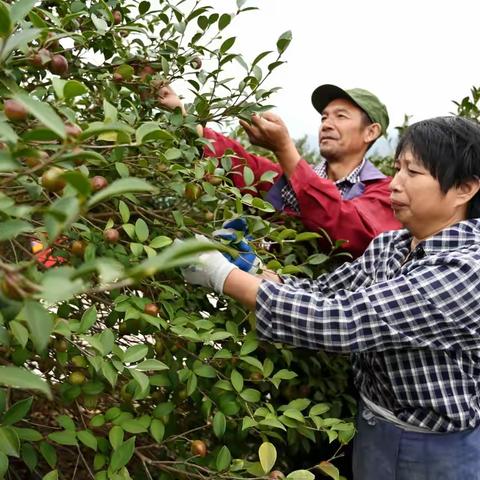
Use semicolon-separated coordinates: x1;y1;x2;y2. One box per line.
184;117;480;480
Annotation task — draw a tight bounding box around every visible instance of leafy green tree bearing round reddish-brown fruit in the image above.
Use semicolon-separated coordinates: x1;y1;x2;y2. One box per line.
0;0;354;480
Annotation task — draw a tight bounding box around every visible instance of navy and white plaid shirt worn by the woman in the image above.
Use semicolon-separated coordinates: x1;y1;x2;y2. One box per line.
256;219;480;432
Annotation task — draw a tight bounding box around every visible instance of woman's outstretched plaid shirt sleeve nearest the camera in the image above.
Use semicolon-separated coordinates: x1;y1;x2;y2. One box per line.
255;258;480;353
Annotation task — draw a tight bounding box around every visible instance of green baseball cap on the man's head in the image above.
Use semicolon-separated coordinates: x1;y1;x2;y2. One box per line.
312;84;389;135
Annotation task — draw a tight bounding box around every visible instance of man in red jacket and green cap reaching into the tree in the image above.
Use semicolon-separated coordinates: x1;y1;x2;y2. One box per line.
159;84;400;257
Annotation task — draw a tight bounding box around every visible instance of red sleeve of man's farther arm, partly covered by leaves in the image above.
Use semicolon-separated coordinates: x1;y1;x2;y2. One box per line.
203;128;282;194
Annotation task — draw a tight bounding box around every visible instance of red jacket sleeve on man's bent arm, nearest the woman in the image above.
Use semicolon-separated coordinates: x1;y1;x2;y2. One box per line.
289;159;402;257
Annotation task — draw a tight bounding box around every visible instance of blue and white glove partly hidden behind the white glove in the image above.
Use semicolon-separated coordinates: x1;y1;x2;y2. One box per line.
213;217;264;274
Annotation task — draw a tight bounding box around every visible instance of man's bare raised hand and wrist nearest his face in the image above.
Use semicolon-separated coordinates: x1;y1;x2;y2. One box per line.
240;112;301;176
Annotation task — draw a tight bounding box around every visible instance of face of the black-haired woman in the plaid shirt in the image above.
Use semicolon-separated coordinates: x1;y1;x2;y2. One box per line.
390;149;466;240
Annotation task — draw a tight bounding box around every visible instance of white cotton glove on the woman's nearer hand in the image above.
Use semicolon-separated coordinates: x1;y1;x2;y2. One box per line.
182;235;238;293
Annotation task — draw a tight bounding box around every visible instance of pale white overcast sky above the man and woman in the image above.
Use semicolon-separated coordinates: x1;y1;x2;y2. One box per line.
218;0;480;142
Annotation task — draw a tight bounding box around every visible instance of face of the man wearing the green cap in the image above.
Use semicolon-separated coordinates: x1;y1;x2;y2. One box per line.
318;98;369;160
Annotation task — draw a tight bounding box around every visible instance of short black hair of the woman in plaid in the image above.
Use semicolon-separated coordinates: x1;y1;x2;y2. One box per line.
395;116;480;218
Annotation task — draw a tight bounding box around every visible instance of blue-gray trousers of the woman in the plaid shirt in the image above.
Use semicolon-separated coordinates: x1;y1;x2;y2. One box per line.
353;404;480;480
